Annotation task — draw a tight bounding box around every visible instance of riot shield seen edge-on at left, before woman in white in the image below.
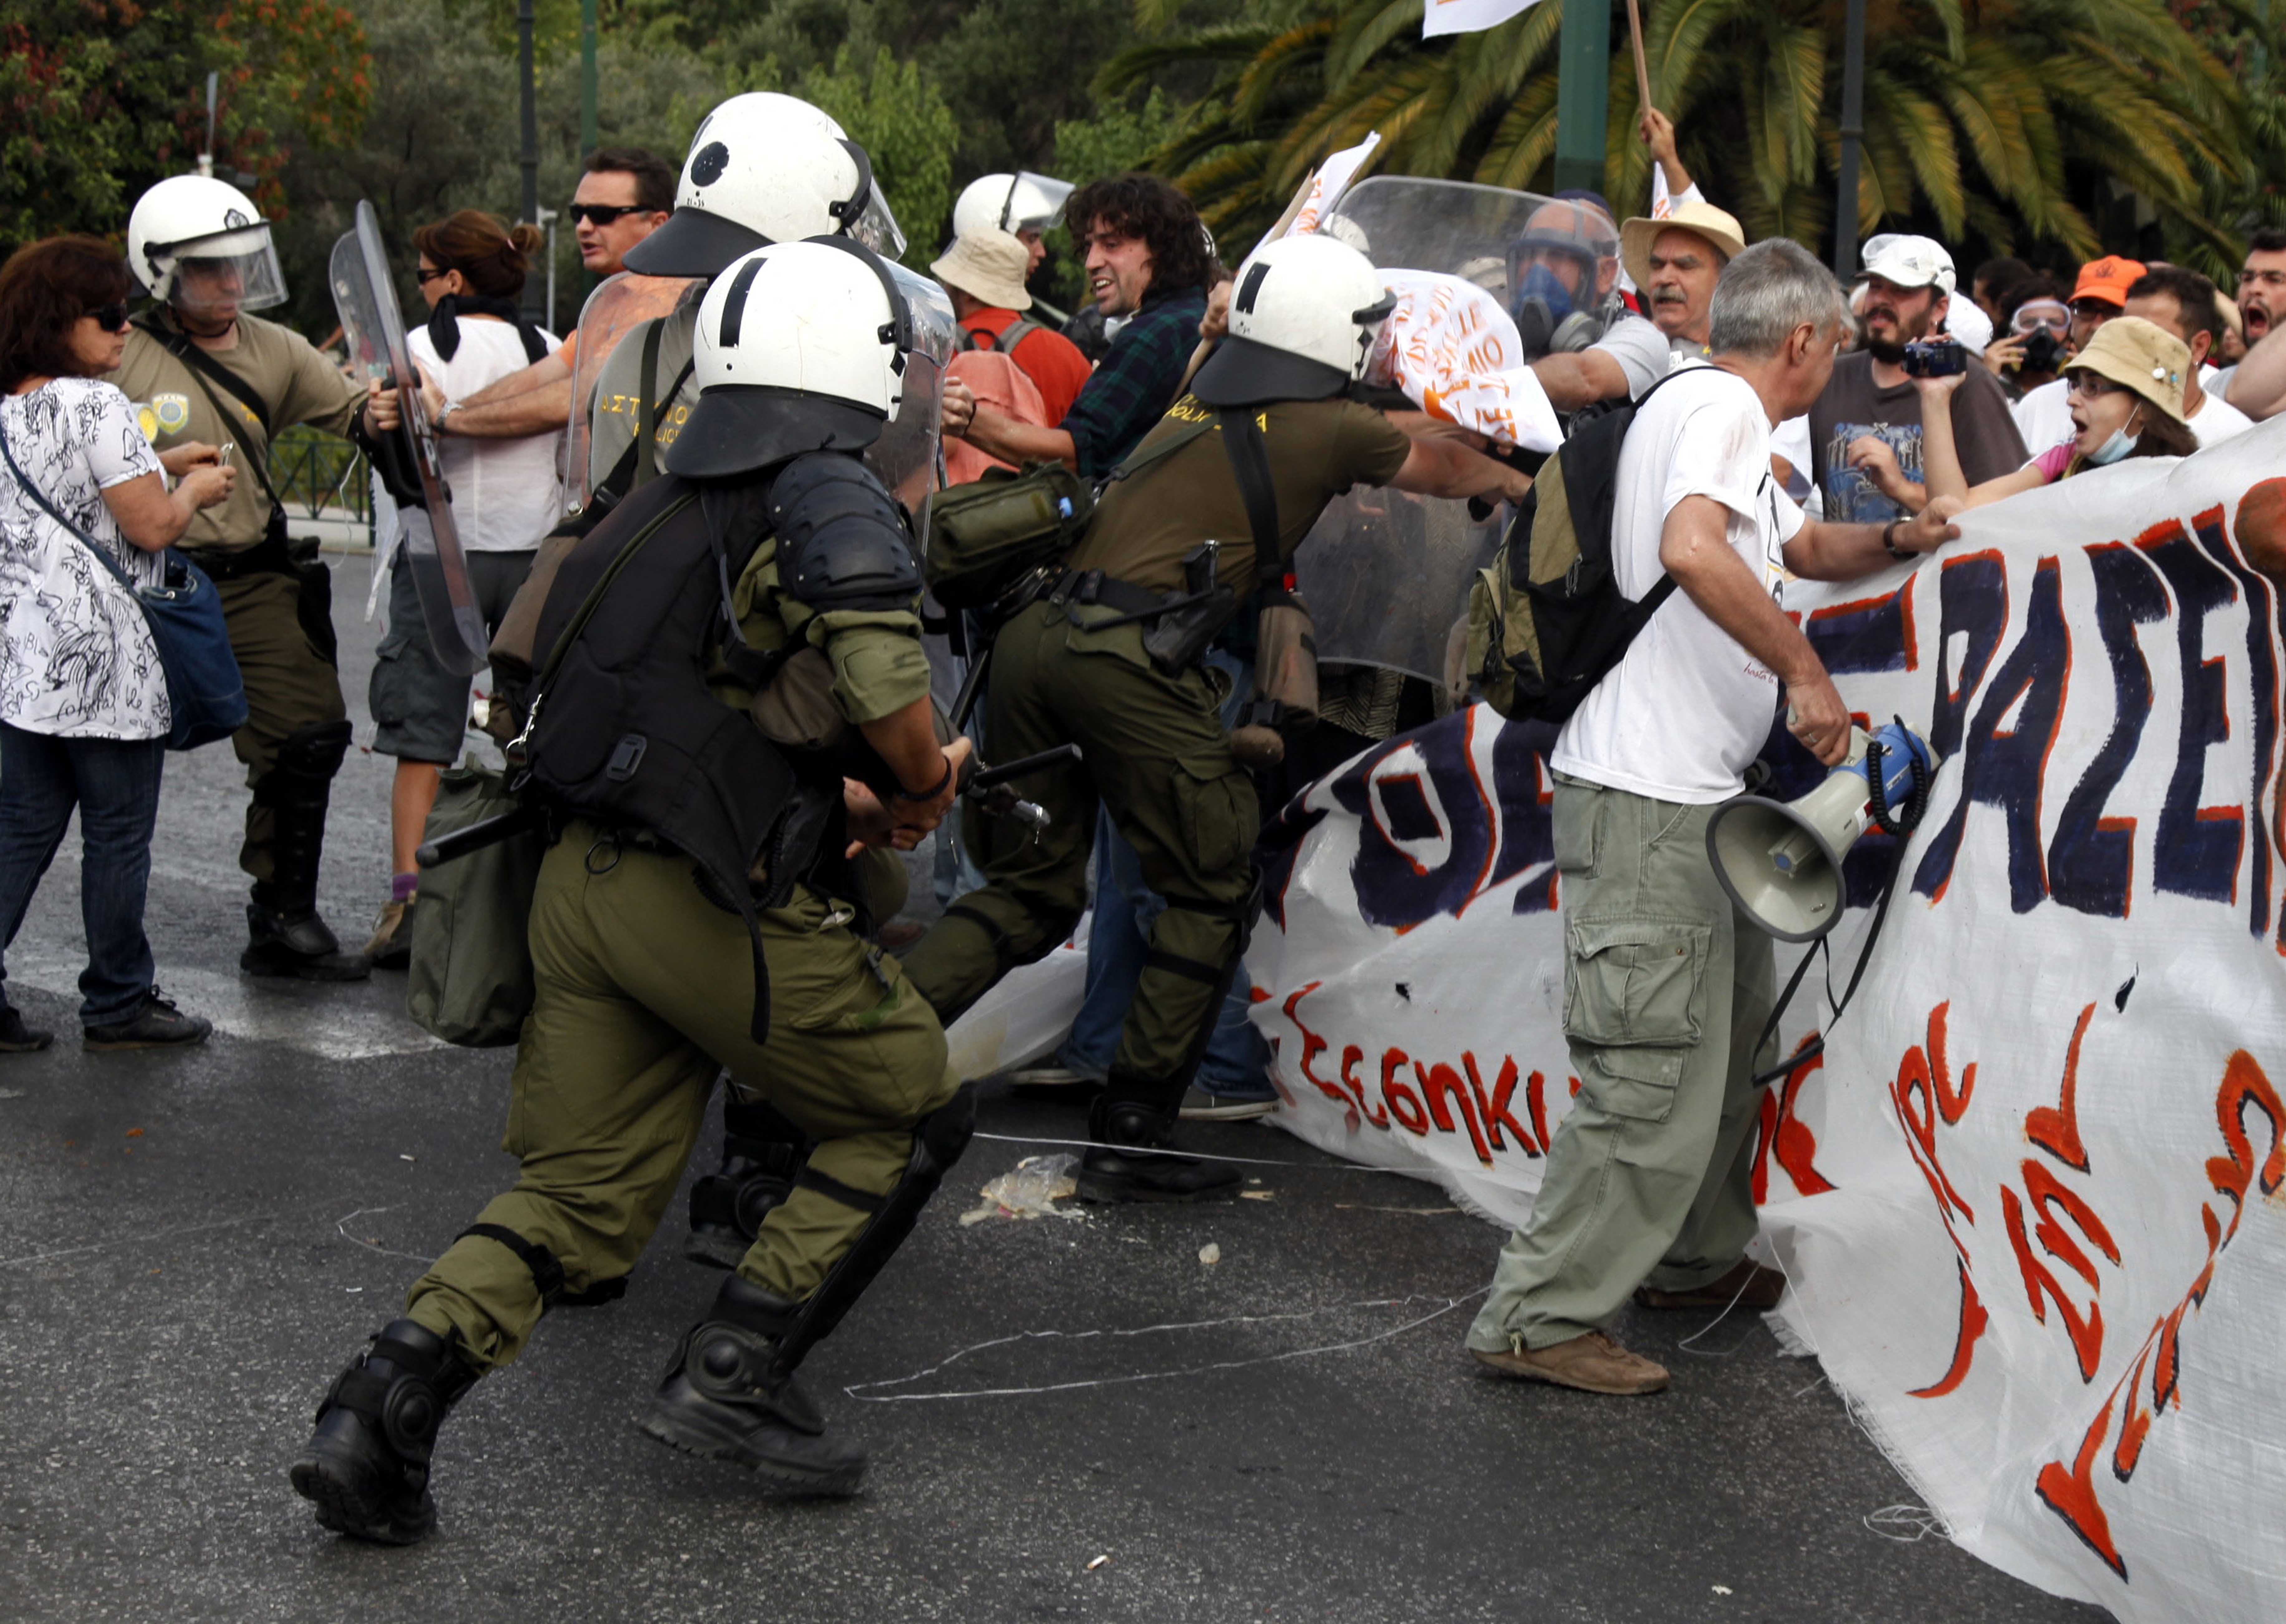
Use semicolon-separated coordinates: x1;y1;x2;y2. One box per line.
327;199;492;676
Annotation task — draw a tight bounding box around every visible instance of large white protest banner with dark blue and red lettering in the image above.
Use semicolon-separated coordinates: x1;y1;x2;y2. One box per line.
1248;423;2286;1624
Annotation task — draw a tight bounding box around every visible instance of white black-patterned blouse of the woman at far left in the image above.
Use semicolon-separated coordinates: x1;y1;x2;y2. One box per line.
0;377;174;738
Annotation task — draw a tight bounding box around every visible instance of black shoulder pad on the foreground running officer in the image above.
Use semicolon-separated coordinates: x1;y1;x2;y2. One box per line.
770;452;921;612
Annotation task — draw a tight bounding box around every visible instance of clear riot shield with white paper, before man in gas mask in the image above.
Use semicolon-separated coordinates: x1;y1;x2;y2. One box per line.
1294;176;1619;683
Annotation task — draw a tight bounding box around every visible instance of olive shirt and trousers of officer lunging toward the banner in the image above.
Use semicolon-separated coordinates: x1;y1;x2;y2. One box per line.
905;395;1410;1115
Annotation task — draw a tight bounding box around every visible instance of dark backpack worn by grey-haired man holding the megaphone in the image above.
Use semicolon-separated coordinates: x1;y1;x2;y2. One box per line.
1468;370;1687;722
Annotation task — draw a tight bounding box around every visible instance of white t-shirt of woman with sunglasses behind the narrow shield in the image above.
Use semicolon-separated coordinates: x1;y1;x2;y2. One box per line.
407;315;565;553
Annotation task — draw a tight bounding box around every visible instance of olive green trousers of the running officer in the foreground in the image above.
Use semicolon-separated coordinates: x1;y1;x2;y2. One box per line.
405;822;955;1373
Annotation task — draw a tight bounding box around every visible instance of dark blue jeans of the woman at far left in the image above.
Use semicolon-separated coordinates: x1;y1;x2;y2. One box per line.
0;722;167;1026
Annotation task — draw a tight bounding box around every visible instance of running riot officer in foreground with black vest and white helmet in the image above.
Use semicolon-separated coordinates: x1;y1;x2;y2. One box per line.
293;240;972;1544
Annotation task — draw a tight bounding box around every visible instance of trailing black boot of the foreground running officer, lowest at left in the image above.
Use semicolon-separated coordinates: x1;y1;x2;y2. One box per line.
290;1320;475;1544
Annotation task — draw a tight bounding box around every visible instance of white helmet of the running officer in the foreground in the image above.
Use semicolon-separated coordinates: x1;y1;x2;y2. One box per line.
665;237;912;480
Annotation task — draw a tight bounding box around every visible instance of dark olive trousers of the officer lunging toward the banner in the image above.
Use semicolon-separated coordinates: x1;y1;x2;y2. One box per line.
905;603;1262;1112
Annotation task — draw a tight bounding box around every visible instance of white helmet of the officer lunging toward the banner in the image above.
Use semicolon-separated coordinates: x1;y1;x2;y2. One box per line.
1191;233;1397;407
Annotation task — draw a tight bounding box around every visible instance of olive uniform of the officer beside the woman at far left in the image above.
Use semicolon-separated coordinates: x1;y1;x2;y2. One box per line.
110;315;366;882
